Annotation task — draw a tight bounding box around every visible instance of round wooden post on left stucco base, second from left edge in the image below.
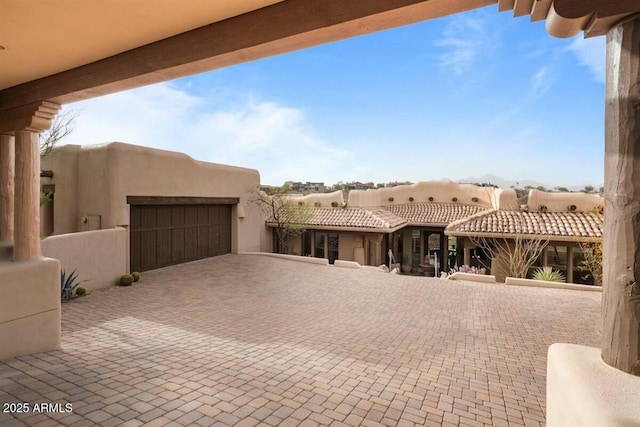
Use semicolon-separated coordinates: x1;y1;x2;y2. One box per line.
13;130;40;261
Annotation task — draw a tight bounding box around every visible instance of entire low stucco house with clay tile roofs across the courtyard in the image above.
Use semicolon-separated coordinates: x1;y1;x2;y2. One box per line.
267;182;603;284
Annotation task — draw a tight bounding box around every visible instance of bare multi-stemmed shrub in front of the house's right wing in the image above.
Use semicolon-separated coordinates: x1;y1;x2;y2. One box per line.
470;211;549;278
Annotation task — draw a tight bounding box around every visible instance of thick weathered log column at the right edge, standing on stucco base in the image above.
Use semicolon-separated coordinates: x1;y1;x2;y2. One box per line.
602;15;640;376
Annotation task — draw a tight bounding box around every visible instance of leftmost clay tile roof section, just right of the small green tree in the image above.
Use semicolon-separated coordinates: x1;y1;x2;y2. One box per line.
267;207;407;231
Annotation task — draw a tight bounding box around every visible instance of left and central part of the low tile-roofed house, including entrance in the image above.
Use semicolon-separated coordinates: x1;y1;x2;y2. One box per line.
267;181;515;273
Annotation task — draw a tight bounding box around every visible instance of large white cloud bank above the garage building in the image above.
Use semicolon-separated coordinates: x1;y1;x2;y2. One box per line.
64;83;353;184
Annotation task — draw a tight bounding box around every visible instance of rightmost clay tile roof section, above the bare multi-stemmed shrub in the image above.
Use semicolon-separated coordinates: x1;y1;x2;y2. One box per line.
446;210;604;240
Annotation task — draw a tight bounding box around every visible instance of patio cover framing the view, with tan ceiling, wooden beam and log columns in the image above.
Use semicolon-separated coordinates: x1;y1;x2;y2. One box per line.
0;0;640;375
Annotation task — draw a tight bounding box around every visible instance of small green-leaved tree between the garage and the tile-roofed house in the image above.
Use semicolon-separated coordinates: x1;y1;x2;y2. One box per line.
251;183;313;254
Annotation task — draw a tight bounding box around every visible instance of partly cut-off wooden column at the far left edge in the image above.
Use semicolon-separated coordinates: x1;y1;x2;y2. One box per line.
0;134;15;241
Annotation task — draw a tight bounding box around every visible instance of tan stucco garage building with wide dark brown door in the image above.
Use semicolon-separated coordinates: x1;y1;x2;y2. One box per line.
41;143;268;271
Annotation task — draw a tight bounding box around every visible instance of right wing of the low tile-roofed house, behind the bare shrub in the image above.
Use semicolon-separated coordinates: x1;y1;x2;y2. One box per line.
445;190;604;285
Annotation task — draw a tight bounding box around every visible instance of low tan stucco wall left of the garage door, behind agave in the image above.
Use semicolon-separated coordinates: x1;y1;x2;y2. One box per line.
41;227;128;290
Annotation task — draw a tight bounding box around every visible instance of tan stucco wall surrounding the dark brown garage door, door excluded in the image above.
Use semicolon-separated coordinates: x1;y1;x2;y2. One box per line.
42;142;270;252
